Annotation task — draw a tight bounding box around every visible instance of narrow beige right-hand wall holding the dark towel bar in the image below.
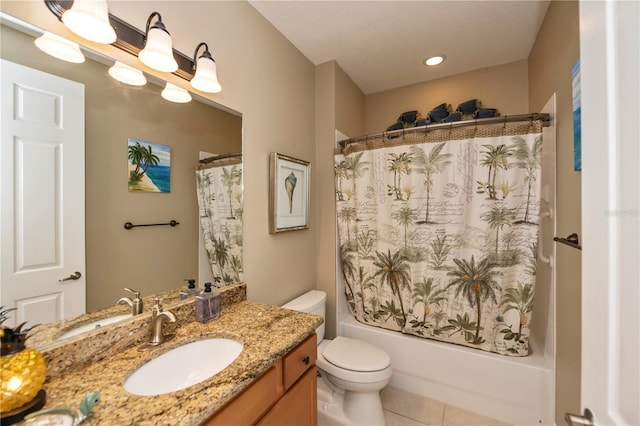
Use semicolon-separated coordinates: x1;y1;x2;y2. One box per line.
529;1;581;424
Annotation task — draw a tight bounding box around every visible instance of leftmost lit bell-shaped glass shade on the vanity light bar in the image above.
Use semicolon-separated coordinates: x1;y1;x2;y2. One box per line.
62;0;117;44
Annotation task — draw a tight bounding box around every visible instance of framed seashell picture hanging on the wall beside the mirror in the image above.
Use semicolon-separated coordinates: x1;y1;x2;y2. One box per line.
269;152;311;234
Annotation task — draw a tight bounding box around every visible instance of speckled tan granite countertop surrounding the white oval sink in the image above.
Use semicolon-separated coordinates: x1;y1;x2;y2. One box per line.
37;301;322;425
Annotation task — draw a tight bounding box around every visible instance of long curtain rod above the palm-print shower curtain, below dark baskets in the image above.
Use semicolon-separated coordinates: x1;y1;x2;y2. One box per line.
338;112;551;148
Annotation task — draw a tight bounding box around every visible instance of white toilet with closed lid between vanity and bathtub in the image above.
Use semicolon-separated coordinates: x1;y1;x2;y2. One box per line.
283;290;393;426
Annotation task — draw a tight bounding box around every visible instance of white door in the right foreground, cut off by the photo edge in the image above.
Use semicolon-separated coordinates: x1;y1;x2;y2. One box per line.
580;1;640;425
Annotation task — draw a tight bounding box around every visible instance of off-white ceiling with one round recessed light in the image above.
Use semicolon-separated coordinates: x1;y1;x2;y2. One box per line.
249;0;549;94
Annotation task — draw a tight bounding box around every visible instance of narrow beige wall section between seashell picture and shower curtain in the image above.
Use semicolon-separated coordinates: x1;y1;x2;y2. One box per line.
316;61;364;338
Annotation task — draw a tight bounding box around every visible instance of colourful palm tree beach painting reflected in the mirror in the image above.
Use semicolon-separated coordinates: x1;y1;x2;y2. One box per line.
128;139;171;192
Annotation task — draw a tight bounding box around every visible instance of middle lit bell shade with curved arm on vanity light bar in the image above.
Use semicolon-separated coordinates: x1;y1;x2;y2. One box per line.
138;12;178;72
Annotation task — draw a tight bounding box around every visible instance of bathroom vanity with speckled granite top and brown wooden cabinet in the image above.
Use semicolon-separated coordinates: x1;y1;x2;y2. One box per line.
29;284;322;425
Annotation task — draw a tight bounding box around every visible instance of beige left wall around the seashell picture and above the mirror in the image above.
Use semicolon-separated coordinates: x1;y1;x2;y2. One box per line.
0;0;316;310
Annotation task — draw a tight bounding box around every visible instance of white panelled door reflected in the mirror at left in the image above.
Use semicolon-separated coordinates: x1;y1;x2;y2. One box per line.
0;60;85;326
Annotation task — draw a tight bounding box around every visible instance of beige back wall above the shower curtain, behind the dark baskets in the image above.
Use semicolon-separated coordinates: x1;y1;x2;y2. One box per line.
365;61;529;134
